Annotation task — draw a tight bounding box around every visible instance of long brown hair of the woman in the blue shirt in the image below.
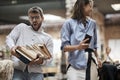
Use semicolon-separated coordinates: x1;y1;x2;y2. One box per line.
71;0;90;23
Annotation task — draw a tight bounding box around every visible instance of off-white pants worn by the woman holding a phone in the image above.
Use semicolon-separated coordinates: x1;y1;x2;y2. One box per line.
67;54;98;80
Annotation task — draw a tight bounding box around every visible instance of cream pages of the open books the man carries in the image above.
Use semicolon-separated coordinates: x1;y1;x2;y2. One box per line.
17;44;51;60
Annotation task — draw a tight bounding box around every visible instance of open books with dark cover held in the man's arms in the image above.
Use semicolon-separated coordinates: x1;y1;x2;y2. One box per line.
15;44;52;64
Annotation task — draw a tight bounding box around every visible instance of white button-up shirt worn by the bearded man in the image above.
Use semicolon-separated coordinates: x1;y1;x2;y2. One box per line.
6;23;53;73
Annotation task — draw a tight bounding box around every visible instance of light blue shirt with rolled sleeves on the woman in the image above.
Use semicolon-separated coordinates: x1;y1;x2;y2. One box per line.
61;18;97;69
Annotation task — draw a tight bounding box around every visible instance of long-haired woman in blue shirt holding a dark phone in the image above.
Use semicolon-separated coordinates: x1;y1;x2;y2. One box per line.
61;0;100;80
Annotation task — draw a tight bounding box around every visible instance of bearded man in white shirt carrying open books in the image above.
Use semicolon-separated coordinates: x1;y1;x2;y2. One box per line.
6;6;53;80
